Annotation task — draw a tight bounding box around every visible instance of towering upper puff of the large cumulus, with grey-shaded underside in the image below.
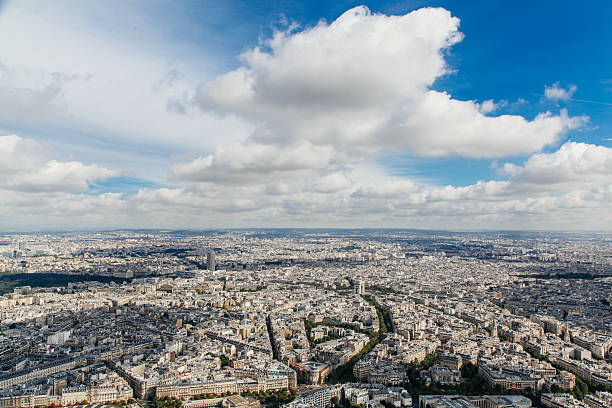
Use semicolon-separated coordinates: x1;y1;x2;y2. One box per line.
201;6;462;112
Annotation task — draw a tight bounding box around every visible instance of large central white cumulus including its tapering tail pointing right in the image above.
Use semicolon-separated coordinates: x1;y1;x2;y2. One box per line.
198;6;583;161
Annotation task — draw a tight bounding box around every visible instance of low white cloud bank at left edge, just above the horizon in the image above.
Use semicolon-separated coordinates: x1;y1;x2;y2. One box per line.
0;135;129;230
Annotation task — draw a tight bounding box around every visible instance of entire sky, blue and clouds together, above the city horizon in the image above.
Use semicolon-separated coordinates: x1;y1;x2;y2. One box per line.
0;0;612;229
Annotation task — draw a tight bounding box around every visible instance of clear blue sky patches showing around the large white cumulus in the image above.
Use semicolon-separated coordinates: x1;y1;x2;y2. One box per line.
88;0;612;185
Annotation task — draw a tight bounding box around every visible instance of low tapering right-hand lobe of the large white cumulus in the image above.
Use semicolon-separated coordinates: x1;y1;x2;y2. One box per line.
376;91;585;158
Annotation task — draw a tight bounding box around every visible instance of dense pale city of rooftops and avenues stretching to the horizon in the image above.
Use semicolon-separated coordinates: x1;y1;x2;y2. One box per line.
0;230;612;408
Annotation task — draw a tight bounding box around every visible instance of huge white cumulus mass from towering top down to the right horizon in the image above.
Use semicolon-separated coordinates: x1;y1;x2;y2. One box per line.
139;7;612;228
